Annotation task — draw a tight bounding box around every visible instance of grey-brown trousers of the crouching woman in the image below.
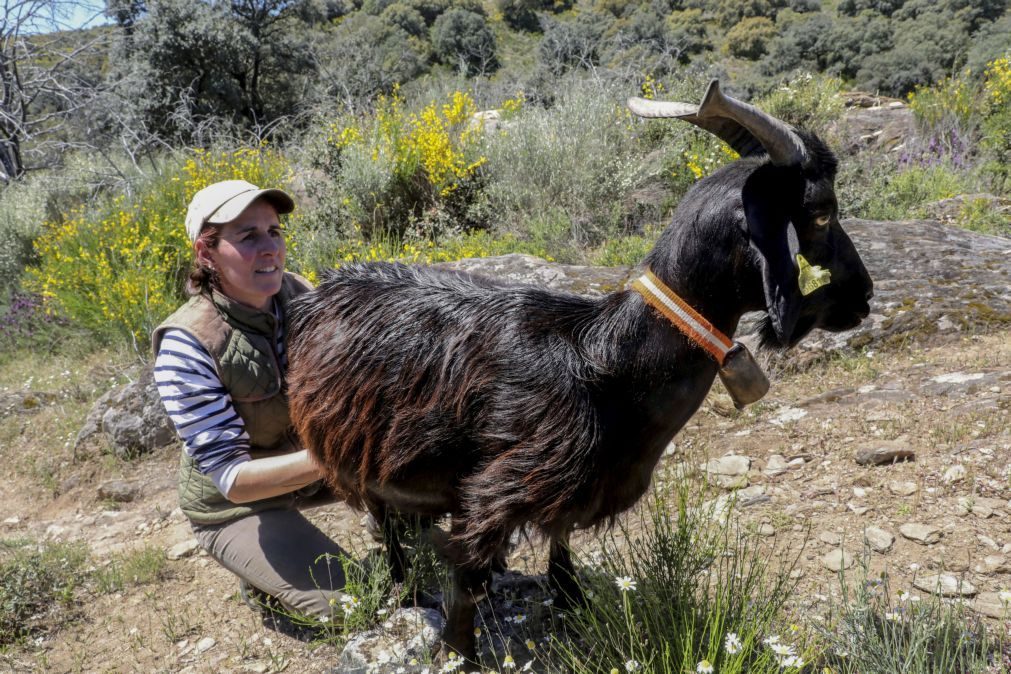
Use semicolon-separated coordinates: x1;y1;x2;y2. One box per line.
193;508;347;616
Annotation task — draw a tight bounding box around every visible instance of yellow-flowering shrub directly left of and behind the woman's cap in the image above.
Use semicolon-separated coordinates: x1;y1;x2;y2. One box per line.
27;148;290;349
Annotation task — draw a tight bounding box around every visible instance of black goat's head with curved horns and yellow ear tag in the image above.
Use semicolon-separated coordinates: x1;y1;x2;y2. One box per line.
629;80;872;348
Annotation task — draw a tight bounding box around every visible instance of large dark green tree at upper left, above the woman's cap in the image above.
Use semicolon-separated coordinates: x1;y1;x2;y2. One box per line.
113;0;319;141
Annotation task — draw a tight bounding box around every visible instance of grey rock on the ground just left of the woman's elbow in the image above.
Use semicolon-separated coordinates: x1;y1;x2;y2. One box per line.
77;367;176;458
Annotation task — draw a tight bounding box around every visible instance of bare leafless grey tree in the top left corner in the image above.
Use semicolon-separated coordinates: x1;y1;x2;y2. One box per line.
0;0;104;184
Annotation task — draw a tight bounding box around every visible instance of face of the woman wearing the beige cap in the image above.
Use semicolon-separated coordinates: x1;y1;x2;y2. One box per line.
196;199;285;311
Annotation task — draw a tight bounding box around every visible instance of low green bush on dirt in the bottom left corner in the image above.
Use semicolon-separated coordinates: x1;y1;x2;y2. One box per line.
0;541;88;648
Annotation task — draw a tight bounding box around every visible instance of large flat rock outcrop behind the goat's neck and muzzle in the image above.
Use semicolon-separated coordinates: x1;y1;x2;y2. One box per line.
440;219;1011;368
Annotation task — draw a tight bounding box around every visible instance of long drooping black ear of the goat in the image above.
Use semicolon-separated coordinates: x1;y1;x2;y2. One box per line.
741;164;804;347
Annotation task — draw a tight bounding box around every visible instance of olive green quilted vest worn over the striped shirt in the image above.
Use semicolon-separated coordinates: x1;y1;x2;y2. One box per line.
152;272;311;524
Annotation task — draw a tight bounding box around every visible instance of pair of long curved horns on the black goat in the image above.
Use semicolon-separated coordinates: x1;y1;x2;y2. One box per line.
628;80;808;166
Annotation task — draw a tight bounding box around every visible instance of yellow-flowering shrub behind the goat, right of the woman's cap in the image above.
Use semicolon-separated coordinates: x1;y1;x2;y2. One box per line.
324;90;485;236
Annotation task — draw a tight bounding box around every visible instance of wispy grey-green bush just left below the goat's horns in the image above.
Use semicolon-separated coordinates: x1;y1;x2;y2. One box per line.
485;78;687;246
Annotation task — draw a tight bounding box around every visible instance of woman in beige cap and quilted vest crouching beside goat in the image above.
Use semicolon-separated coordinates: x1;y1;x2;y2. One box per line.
153;180;344;616
